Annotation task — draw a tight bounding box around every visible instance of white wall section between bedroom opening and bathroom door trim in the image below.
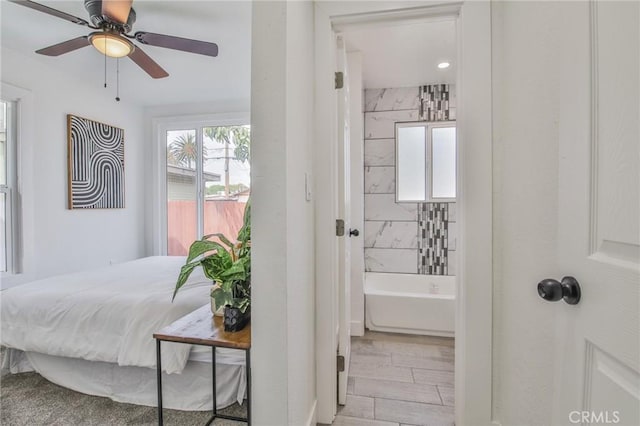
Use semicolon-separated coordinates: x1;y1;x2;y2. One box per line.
251;2;315;426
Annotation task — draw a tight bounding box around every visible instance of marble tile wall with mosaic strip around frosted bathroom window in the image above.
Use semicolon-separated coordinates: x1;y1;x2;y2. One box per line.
364;85;457;275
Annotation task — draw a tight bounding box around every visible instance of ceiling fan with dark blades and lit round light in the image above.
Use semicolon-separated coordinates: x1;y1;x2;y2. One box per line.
9;0;218;78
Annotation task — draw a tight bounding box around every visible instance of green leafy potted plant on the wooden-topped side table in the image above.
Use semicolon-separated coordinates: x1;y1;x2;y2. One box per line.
171;201;251;331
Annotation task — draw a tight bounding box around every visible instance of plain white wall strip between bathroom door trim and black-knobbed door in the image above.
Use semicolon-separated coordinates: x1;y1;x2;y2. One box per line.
492;2;568;426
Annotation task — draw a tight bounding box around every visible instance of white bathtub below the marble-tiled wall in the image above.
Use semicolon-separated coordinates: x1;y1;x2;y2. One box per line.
364;272;456;337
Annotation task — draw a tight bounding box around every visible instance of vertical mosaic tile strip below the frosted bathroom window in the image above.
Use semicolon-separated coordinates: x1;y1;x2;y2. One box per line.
418;203;449;275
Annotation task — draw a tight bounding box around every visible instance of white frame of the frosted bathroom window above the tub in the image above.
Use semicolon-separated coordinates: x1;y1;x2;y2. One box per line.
394;120;458;203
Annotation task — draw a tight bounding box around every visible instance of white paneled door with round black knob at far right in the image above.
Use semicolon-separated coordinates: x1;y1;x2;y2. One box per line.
552;1;640;425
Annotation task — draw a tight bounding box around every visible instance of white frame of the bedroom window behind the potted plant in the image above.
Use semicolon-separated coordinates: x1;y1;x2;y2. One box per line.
151;112;251;256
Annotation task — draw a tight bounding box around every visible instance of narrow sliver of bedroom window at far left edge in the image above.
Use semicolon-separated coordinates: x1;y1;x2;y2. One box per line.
0;100;17;273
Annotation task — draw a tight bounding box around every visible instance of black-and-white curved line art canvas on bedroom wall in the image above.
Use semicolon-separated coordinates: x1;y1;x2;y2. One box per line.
67;114;124;209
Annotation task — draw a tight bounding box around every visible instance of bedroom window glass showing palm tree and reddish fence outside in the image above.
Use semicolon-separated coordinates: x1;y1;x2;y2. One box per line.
164;125;251;256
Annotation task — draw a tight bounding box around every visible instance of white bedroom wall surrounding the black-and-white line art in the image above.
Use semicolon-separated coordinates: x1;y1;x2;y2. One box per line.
0;48;145;285
